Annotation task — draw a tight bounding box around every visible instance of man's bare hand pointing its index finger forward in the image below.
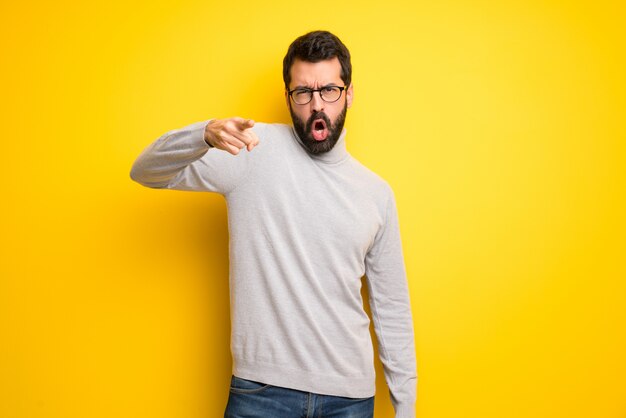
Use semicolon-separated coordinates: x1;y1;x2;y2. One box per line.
204;117;259;155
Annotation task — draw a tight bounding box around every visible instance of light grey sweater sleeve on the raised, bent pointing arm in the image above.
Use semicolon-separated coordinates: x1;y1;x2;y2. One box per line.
130;120;260;194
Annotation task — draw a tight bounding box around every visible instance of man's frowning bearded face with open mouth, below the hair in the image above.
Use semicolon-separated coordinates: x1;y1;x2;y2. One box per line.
285;57;353;154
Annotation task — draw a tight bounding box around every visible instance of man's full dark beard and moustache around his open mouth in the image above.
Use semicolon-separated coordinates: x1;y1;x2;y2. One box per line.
289;101;348;154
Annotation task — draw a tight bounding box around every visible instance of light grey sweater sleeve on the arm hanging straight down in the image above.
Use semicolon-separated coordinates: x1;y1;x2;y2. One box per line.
365;189;417;418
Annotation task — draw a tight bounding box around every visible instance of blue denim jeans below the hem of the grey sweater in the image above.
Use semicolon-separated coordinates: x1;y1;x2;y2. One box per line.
224;376;374;418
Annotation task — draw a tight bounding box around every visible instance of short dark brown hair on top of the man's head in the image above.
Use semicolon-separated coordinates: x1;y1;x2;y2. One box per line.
283;30;352;90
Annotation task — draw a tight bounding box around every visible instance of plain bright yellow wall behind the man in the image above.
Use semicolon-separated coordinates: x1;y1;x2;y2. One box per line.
0;0;626;418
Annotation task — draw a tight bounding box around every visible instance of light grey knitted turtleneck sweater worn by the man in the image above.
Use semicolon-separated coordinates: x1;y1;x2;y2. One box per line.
131;121;417;418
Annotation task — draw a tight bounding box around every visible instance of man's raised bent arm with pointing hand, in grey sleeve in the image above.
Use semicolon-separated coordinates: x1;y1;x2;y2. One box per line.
130;118;259;194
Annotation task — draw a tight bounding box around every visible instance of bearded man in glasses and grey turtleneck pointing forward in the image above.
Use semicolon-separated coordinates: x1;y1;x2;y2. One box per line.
131;31;417;418
